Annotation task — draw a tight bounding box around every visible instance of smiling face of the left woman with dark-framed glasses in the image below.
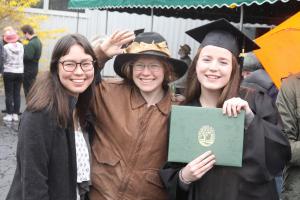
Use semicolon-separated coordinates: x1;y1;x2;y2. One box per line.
58;45;94;96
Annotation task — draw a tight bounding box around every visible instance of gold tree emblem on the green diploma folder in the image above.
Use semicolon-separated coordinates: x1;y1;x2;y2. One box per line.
198;125;216;147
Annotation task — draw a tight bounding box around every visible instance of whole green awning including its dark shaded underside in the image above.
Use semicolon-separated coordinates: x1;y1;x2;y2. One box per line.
69;0;300;25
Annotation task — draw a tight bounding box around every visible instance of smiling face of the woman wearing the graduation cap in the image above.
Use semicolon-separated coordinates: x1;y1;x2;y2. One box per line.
196;45;232;92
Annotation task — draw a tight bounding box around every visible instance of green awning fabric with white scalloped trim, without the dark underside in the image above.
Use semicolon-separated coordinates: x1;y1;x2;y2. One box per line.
69;0;294;9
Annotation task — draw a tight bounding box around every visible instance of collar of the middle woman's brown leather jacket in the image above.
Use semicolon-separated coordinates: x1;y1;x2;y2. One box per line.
130;86;172;115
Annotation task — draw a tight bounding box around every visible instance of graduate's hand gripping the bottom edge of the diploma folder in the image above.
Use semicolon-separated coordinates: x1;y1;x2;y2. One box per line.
181;151;216;182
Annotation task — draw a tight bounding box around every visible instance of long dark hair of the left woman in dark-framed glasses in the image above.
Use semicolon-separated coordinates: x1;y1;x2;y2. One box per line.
27;34;99;128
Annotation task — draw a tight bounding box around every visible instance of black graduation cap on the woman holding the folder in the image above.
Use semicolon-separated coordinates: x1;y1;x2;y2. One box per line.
186;19;260;57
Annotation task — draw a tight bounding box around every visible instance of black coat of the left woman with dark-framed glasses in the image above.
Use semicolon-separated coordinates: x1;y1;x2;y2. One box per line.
6;111;77;200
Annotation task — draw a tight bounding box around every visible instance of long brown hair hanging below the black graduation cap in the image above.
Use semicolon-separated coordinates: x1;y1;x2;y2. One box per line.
184;48;240;108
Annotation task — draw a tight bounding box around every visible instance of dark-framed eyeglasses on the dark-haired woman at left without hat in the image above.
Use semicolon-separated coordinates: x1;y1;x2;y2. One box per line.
59;60;95;72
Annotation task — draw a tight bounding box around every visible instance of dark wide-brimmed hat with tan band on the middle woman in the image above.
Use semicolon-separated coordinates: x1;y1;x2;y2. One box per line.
114;32;188;78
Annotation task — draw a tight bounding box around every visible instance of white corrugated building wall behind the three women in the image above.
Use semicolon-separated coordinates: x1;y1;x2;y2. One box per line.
28;9;253;76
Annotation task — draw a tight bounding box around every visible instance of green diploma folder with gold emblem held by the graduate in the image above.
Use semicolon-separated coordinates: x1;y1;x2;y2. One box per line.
168;105;245;167
